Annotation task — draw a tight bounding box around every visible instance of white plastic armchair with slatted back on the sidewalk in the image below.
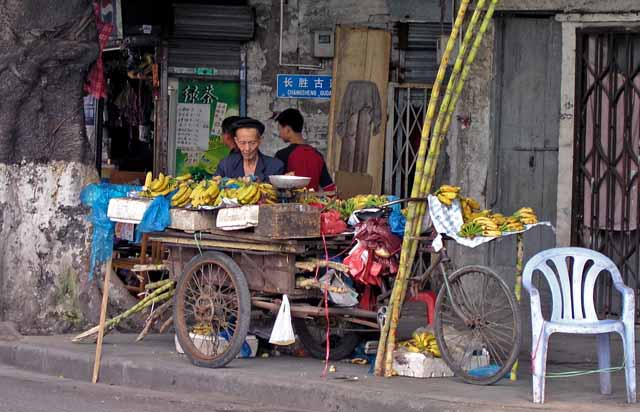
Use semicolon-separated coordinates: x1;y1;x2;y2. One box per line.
523;247;636;403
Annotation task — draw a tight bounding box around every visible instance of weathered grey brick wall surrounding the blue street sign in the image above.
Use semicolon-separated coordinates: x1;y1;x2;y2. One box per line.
247;0;390;154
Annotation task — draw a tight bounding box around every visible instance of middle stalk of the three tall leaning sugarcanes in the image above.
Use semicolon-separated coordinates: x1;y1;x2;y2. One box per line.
385;0;486;376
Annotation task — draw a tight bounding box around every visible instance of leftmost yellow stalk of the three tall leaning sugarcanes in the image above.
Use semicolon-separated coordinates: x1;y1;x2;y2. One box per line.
375;0;470;376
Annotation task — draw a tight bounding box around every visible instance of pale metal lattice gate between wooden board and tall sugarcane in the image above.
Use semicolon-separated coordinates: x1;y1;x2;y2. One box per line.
384;83;431;198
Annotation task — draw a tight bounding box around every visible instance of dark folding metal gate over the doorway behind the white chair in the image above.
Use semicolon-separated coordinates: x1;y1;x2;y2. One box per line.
572;28;640;315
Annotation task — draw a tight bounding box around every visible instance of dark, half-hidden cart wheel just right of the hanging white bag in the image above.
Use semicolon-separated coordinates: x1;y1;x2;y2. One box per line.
293;318;361;360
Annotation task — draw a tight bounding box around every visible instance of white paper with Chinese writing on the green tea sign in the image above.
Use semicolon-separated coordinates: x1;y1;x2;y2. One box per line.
176;103;210;165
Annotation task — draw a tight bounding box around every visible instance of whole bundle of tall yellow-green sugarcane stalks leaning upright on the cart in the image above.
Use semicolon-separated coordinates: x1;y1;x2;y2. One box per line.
375;0;498;376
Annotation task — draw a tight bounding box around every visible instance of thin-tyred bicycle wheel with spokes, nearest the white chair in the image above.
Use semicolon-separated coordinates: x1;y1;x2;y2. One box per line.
435;266;522;385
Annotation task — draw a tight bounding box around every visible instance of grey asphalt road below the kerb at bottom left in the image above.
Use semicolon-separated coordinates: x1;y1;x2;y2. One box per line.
0;364;310;412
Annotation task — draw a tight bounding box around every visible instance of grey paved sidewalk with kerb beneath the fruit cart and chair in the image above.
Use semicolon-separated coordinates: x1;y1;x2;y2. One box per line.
0;333;638;412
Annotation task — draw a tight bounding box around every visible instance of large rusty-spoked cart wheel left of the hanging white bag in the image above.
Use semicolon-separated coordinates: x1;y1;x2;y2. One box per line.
173;252;251;368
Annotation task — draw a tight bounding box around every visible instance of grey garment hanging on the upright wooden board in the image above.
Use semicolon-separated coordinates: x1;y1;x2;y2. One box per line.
336;80;382;173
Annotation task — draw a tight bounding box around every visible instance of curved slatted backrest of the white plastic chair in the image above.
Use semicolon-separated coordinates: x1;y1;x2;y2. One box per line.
522;247;623;321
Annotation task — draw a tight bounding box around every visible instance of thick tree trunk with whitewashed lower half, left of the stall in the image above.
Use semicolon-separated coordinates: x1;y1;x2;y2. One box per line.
0;0;141;333
